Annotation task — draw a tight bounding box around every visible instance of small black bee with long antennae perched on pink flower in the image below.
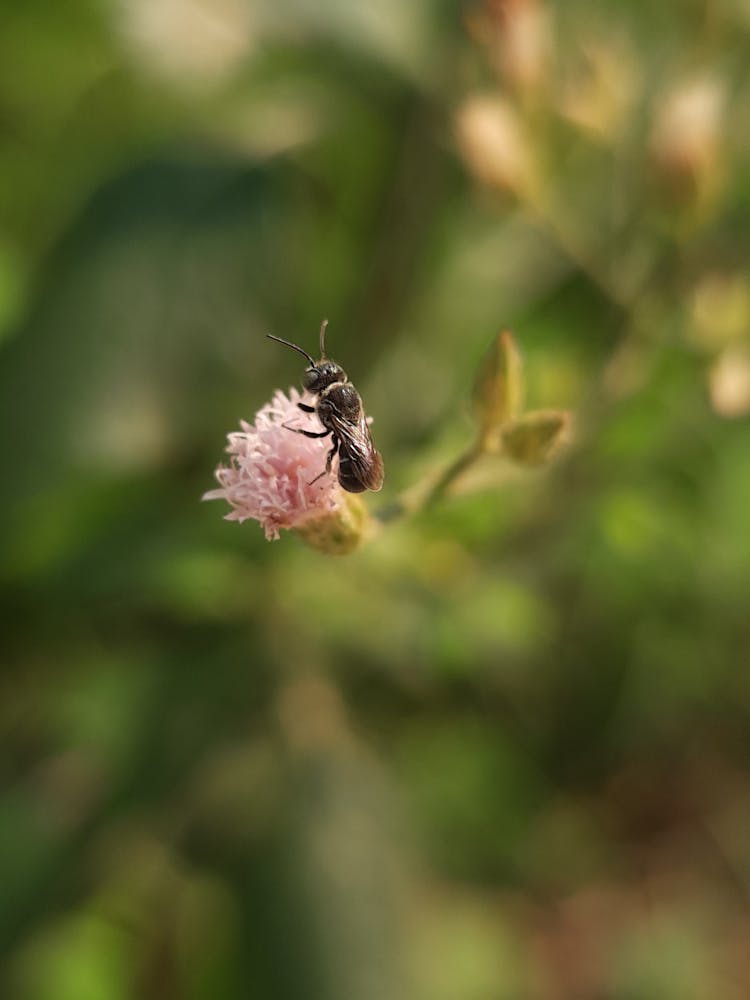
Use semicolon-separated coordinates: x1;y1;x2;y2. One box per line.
268;319;383;493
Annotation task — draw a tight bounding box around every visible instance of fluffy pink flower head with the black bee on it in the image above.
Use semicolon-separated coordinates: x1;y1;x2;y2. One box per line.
203;389;347;541
